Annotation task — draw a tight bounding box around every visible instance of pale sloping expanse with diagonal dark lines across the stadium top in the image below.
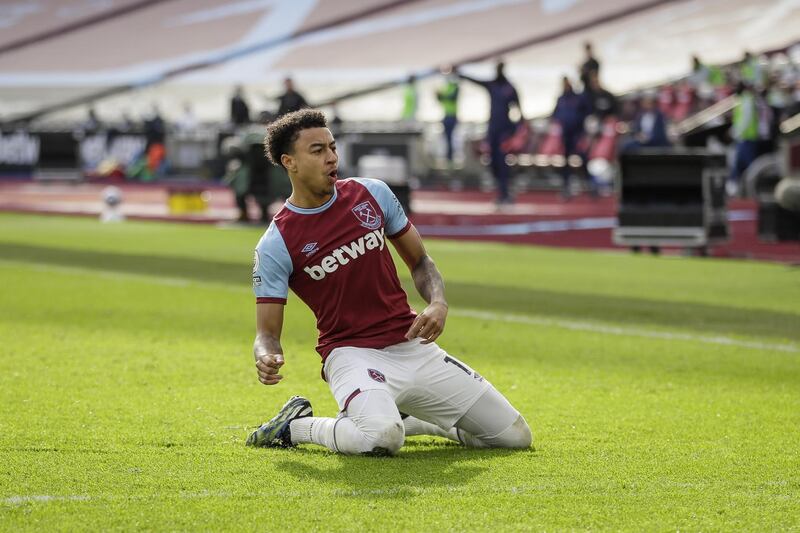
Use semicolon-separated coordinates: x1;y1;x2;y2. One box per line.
0;0;800;120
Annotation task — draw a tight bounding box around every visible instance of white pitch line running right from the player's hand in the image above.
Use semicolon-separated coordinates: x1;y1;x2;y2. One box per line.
450;309;800;353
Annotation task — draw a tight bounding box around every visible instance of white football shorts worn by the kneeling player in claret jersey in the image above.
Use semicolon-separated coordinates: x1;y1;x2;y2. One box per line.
323;339;492;430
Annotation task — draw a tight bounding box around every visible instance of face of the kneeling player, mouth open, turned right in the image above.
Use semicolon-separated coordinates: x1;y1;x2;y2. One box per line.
287;128;339;199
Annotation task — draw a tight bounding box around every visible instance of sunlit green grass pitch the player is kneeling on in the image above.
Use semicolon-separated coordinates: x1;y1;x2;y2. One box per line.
0;215;800;531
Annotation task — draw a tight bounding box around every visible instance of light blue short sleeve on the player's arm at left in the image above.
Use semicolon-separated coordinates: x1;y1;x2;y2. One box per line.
253;222;292;304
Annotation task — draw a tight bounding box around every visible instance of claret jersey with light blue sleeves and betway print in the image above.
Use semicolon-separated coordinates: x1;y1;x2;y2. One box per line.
253;178;415;360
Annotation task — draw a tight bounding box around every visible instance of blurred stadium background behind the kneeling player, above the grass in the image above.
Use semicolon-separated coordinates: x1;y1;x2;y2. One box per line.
0;0;800;262
